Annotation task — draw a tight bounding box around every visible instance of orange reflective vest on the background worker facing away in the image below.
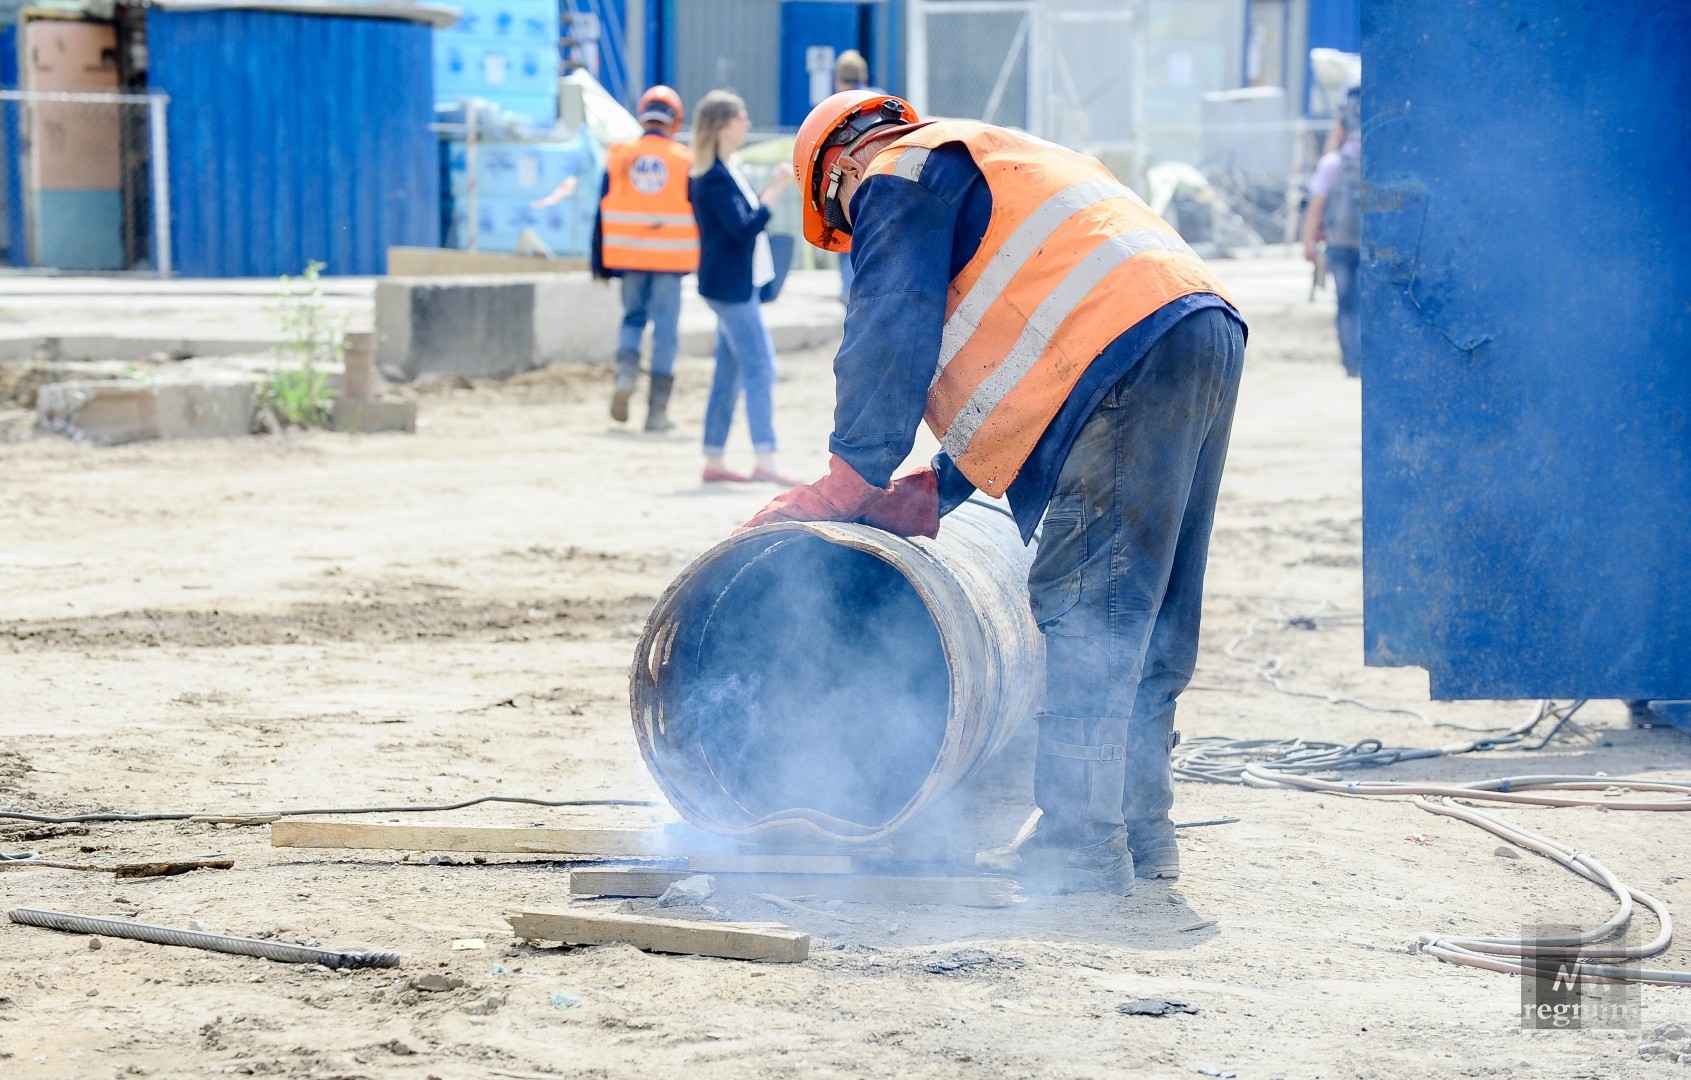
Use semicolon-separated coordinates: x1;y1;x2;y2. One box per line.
599;135;698;274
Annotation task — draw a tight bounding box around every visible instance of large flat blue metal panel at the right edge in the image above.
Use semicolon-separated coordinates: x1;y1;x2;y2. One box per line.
1361;0;1691;698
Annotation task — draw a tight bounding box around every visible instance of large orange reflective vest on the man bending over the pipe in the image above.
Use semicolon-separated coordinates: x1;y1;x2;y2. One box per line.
866;120;1231;497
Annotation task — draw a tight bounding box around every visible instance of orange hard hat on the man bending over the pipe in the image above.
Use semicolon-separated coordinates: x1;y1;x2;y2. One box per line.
793;90;917;252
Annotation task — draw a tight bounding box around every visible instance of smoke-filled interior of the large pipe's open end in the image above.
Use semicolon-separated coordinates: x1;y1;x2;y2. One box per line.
665;537;950;826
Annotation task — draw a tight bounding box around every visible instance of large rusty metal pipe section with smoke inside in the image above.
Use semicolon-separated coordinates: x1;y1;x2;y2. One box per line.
631;502;1045;843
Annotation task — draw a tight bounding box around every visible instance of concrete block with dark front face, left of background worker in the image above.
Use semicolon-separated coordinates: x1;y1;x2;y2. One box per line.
375;274;622;380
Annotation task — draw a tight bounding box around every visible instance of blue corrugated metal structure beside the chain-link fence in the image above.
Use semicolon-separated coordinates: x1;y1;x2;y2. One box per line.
147;8;440;277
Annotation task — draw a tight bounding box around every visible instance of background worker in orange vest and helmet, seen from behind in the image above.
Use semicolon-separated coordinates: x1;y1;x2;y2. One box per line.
594;86;698;431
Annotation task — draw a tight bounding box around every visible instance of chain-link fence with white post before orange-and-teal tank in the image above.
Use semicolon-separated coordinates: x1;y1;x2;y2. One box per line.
0;90;171;275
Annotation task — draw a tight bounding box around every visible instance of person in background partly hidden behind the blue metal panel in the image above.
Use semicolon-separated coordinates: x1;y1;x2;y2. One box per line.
1304;86;1363;377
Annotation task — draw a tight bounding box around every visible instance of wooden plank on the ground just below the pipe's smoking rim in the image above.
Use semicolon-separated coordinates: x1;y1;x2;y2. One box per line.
570;867;1021;908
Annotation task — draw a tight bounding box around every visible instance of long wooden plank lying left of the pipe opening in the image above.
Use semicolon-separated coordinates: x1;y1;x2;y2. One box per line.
271;820;670;855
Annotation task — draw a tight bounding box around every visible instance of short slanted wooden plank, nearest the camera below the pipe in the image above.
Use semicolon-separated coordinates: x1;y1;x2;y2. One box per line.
506;911;810;963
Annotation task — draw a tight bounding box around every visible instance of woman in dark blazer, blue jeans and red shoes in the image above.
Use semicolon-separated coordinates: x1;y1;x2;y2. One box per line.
690;90;793;485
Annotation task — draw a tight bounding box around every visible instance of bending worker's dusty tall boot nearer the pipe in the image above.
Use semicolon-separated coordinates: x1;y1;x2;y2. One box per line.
976;713;1133;896
